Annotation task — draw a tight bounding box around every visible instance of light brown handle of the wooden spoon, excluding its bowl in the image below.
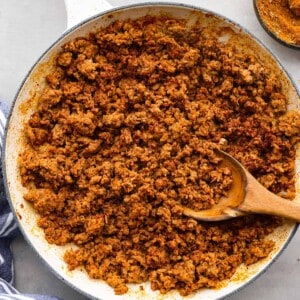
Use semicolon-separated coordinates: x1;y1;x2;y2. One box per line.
238;171;300;222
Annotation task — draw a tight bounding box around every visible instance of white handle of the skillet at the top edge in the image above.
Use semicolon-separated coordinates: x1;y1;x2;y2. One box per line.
65;0;113;29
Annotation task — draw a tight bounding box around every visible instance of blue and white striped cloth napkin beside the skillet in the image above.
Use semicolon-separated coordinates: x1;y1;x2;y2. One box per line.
0;102;59;300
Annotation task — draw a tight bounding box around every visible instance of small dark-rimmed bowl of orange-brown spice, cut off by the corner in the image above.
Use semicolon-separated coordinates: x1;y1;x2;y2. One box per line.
253;0;300;49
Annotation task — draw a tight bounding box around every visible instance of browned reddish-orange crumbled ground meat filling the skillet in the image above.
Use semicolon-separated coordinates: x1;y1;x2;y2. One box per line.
19;16;300;295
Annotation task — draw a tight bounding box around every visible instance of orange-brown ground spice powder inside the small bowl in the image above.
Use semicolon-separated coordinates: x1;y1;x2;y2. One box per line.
256;0;300;46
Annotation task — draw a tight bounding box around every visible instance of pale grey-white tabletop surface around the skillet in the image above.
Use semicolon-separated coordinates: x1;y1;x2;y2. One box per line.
0;0;300;300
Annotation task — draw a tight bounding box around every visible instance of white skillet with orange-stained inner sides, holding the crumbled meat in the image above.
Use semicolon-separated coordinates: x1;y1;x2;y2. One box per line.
2;0;300;300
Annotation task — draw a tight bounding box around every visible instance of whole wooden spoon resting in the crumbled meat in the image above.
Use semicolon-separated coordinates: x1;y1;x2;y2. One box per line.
183;151;300;222
